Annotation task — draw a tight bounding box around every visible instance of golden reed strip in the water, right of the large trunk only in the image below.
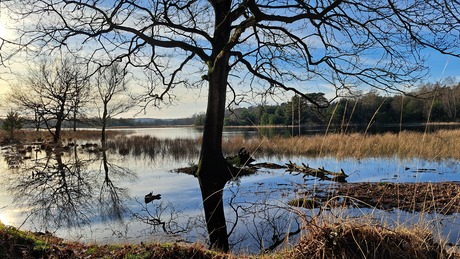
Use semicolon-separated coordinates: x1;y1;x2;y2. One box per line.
223;130;460;159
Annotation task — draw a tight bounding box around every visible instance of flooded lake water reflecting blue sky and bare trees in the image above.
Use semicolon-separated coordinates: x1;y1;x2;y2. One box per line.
0;127;460;252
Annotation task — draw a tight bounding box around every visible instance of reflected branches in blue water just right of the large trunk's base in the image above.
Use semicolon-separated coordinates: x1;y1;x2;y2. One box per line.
226;187;303;252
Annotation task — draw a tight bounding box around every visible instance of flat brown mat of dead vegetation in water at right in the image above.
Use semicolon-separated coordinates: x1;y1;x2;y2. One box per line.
291;182;460;215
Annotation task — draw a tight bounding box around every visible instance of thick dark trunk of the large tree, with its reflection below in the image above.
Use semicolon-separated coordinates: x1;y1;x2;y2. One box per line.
197;0;232;252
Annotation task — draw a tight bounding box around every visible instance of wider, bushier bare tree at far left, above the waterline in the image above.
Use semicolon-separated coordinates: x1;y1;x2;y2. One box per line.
9;56;88;143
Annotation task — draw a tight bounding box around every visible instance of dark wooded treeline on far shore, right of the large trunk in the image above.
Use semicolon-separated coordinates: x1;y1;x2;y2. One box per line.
195;82;460;126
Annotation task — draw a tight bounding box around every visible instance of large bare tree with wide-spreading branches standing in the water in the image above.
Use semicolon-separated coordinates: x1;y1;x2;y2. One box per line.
0;0;460;250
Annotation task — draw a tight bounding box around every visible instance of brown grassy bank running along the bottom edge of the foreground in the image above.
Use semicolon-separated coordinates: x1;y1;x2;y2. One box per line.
0;220;456;259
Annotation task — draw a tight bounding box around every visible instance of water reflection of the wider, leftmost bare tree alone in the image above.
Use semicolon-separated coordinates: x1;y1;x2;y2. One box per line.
9;149;93;231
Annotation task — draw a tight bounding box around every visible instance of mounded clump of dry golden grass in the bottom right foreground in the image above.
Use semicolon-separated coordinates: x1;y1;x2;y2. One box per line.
286;218;453;259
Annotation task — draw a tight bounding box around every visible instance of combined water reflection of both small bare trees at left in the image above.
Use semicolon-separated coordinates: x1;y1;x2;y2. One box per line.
9;145;135;233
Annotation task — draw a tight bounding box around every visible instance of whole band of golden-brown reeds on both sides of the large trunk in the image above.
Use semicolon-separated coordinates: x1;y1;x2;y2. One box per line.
0;130;460;160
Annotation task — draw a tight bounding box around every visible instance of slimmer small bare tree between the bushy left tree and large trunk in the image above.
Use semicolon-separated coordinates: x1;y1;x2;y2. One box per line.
95;63;134;147
